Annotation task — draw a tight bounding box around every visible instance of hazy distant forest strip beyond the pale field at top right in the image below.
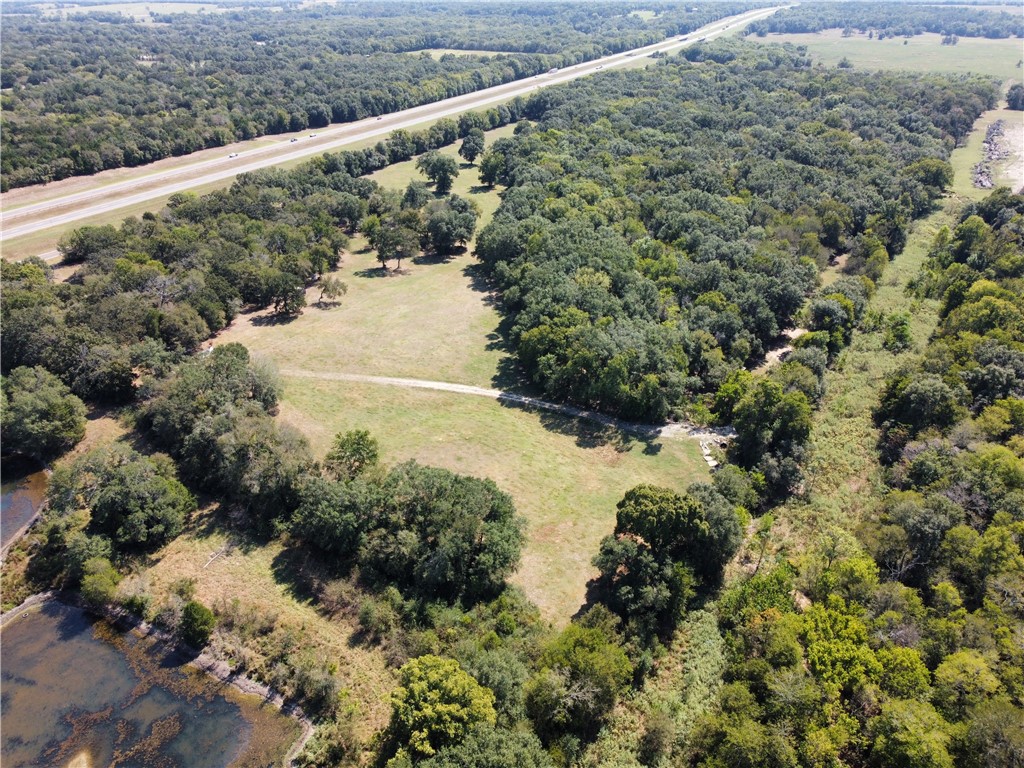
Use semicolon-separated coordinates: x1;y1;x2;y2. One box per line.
744;2;1024;40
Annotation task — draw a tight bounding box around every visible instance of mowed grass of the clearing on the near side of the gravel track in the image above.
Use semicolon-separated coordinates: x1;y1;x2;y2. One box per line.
281;376;709;624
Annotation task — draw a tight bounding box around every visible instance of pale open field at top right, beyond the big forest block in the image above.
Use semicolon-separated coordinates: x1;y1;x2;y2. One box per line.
765;30;1021;81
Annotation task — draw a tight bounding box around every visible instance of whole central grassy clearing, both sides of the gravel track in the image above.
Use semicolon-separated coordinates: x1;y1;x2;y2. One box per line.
218;126;707;623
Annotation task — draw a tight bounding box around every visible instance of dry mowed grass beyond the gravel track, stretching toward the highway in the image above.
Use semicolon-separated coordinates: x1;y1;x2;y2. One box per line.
218;126;513;386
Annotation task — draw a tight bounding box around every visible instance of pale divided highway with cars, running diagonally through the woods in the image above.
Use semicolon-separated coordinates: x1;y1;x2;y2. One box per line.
0;7;776;252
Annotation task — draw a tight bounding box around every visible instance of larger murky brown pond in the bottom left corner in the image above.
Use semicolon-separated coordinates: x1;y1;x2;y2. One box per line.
0;602;299;768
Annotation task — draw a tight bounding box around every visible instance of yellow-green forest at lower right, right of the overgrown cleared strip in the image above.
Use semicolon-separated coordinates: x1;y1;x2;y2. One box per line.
688;188;1024;768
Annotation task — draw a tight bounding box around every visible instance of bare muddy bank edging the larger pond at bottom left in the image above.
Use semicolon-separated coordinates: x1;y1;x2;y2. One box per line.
0;591;313;766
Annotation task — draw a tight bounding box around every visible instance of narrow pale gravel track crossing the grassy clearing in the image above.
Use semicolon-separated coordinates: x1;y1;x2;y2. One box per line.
281;369;735;440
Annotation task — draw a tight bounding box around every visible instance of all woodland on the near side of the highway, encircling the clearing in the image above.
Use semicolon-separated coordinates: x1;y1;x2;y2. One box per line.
0;33;1024;768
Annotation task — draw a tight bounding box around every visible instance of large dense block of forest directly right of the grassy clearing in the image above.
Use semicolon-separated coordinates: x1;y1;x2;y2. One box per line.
477;43;996;434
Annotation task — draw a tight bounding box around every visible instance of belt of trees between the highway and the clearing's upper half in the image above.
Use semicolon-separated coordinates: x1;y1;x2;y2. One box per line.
0;101;512;421
